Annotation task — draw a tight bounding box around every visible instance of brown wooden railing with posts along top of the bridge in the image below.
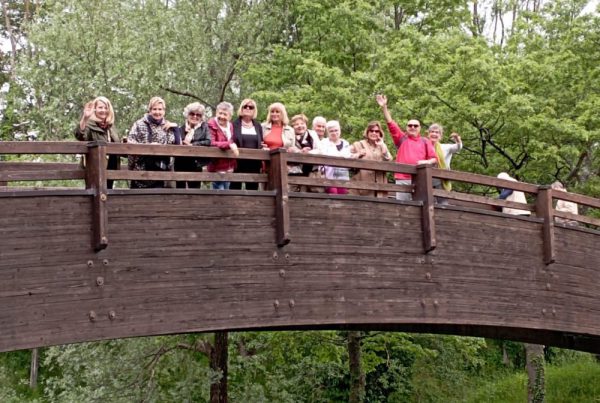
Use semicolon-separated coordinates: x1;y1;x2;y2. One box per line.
0;142;600;256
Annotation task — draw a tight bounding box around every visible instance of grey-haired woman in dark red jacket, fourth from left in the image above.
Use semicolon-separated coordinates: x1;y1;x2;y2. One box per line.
208;102;238;190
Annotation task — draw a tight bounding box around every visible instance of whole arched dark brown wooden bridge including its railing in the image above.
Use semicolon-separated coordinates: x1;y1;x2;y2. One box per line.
0;142;600;353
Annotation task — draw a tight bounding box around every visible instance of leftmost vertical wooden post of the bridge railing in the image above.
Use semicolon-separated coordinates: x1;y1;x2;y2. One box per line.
85;141;108;251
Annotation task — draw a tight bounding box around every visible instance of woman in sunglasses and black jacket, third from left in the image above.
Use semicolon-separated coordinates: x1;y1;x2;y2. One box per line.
175;102;210;189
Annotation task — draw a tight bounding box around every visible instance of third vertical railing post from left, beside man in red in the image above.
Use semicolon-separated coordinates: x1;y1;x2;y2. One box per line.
413;164;436;253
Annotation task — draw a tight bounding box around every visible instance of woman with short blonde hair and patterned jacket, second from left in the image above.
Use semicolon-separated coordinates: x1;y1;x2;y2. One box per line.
127;97;180;189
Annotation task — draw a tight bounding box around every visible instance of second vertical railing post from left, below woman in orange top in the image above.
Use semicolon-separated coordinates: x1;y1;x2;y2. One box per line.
269;148;290;246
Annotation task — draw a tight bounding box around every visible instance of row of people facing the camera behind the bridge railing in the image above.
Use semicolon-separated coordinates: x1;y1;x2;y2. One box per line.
75;95;462;200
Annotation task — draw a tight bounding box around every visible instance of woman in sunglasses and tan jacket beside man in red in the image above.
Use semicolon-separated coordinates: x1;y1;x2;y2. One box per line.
350;121;392;197
